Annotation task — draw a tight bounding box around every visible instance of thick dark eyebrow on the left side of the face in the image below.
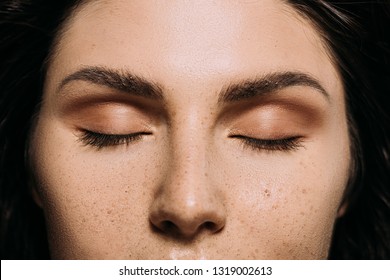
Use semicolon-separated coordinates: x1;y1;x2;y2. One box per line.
57;66;163;100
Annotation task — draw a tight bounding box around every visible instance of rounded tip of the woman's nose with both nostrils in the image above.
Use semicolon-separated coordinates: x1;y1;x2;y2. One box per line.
150;199;225;239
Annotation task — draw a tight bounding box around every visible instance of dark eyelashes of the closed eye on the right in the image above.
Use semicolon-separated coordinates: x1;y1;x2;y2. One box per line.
230;135;302;152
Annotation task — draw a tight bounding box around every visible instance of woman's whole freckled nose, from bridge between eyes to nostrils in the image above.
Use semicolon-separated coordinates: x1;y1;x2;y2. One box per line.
150;110;225;237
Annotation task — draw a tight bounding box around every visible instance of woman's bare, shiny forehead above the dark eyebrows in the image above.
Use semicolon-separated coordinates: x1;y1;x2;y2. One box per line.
48;0;337;96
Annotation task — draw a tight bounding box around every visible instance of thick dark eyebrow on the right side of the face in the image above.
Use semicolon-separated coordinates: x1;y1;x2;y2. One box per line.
218;72;330;103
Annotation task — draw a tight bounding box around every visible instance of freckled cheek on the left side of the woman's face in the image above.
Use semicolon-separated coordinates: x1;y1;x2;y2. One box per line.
31;118;161;259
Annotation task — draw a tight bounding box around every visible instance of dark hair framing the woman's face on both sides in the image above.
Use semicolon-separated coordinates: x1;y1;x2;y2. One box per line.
0;0;390;259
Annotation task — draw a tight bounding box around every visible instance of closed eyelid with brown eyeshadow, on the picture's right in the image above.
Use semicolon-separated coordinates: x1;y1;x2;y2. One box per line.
219;92;328;137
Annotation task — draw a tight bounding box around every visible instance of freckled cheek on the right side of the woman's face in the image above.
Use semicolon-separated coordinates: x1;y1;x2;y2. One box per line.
219;133;349;259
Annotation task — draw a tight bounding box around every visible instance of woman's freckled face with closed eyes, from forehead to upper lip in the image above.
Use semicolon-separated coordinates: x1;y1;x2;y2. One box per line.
30;0;350;259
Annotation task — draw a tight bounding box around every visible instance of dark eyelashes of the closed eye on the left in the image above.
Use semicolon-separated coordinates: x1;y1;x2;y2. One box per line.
79;130;152;149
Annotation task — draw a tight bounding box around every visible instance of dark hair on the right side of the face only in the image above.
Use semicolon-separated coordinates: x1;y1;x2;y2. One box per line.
288;0;390;259
